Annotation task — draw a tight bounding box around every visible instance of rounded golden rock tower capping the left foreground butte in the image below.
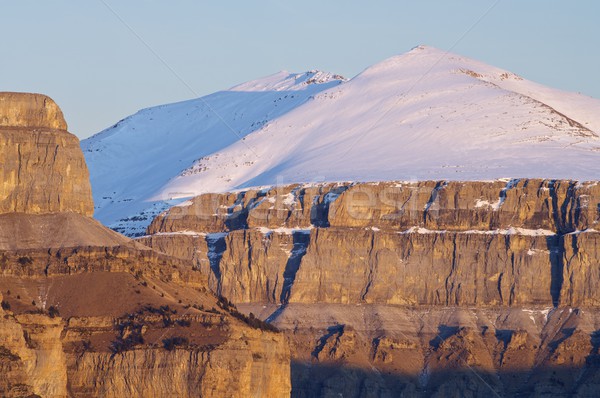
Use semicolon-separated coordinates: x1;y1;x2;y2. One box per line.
0;93;94;216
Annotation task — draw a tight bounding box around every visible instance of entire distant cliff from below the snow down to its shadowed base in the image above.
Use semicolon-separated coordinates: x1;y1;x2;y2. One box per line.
139;179;600;397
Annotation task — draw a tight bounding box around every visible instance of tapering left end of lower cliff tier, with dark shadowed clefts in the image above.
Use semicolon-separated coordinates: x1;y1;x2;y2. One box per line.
138;229;310;304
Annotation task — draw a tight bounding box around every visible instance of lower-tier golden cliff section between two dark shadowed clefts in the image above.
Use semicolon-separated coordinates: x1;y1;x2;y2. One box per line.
290;228;558;306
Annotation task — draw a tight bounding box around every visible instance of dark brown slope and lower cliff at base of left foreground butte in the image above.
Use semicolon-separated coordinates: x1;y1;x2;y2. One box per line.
0;268;290;397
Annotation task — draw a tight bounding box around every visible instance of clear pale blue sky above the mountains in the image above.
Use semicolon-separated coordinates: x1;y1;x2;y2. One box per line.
0;0;600;138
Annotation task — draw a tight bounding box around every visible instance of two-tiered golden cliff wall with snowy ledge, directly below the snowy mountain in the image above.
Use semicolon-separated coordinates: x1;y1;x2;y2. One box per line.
141;180;600;306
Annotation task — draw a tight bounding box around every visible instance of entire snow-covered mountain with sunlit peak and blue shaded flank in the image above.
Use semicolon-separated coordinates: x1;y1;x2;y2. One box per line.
82;46;600;234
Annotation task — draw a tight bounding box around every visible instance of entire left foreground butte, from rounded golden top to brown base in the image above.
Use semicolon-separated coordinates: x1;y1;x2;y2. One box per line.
0;93;291;397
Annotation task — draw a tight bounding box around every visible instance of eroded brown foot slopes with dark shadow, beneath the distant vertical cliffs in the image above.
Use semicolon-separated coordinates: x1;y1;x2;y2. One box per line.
237;304;599;397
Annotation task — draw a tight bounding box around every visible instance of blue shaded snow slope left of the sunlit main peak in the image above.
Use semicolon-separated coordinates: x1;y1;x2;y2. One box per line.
81;71;344;234
